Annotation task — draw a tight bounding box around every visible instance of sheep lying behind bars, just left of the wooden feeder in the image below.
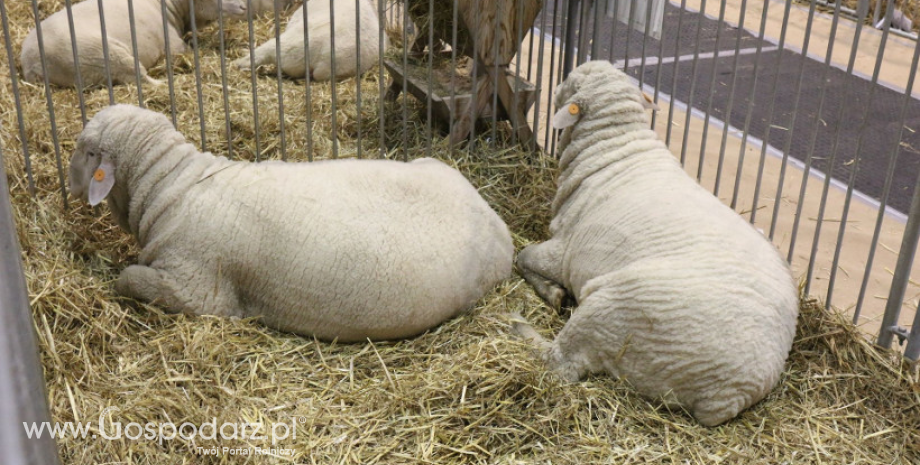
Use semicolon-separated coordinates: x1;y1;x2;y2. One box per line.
234;0;389;81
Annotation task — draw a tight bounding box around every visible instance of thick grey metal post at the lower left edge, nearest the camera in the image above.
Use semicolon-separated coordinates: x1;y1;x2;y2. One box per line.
0;142;61;465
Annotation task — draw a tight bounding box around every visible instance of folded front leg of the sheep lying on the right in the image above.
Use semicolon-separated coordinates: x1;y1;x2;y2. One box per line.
517;240;566;311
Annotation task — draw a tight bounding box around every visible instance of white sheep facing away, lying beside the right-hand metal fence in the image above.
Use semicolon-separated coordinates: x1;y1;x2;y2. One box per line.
515;61;798;425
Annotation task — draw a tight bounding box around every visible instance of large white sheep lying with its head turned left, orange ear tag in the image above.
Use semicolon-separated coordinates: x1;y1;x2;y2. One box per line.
70;105;514;342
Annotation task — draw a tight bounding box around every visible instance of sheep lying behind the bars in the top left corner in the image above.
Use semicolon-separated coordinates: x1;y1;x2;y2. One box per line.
20;0;246;87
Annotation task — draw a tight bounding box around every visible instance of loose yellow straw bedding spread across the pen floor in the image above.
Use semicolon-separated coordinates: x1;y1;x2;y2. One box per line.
0;1;920;464
